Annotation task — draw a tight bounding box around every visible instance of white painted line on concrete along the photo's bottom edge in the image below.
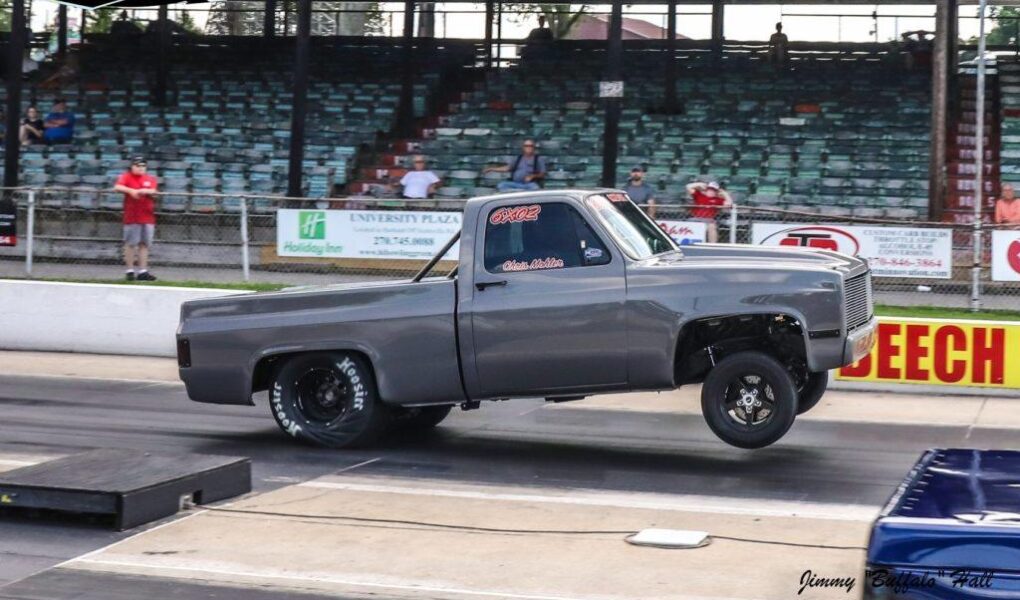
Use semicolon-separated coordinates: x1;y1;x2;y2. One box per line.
79;558;757;600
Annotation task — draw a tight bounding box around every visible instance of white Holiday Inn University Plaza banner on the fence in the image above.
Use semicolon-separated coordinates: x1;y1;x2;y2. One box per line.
276;208;461;259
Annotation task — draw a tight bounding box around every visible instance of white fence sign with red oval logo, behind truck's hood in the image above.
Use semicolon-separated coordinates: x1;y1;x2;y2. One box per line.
751;222;953;280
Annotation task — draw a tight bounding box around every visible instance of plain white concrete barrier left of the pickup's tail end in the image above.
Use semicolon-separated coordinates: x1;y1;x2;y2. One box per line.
0;280;250;356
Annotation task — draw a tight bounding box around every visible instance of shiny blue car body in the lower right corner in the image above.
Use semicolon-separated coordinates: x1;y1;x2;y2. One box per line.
864;449;1020;600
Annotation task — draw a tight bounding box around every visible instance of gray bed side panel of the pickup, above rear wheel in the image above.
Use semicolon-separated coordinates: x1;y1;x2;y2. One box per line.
181;280;464;404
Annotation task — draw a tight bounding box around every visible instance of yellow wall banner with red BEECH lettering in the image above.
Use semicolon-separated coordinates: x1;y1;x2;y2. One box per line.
836;316;1020;389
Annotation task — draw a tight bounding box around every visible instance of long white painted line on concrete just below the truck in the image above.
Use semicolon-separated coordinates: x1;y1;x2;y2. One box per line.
297;480;879;522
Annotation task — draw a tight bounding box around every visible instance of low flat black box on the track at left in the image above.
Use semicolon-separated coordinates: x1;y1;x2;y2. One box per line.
0;449;252;531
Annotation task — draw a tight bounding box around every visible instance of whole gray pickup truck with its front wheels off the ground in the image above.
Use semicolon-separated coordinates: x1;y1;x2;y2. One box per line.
177;190;875;448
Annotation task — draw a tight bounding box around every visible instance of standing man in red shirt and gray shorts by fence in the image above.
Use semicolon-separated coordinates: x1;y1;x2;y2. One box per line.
113;156;156;282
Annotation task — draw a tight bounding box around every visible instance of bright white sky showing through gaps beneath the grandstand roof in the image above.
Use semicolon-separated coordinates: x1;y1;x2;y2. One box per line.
25;0;977;42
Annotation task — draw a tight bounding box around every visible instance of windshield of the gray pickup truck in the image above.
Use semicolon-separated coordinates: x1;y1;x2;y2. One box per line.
585;192;677;259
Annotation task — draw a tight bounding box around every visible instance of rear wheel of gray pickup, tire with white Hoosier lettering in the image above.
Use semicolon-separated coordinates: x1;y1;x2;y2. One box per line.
269;352;390;448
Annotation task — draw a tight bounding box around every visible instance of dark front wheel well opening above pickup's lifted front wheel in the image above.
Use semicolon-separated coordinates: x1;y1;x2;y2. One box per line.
673;313;807;386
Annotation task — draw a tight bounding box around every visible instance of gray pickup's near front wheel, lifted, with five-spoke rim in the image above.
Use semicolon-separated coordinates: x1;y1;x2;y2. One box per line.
702;352;798;448
